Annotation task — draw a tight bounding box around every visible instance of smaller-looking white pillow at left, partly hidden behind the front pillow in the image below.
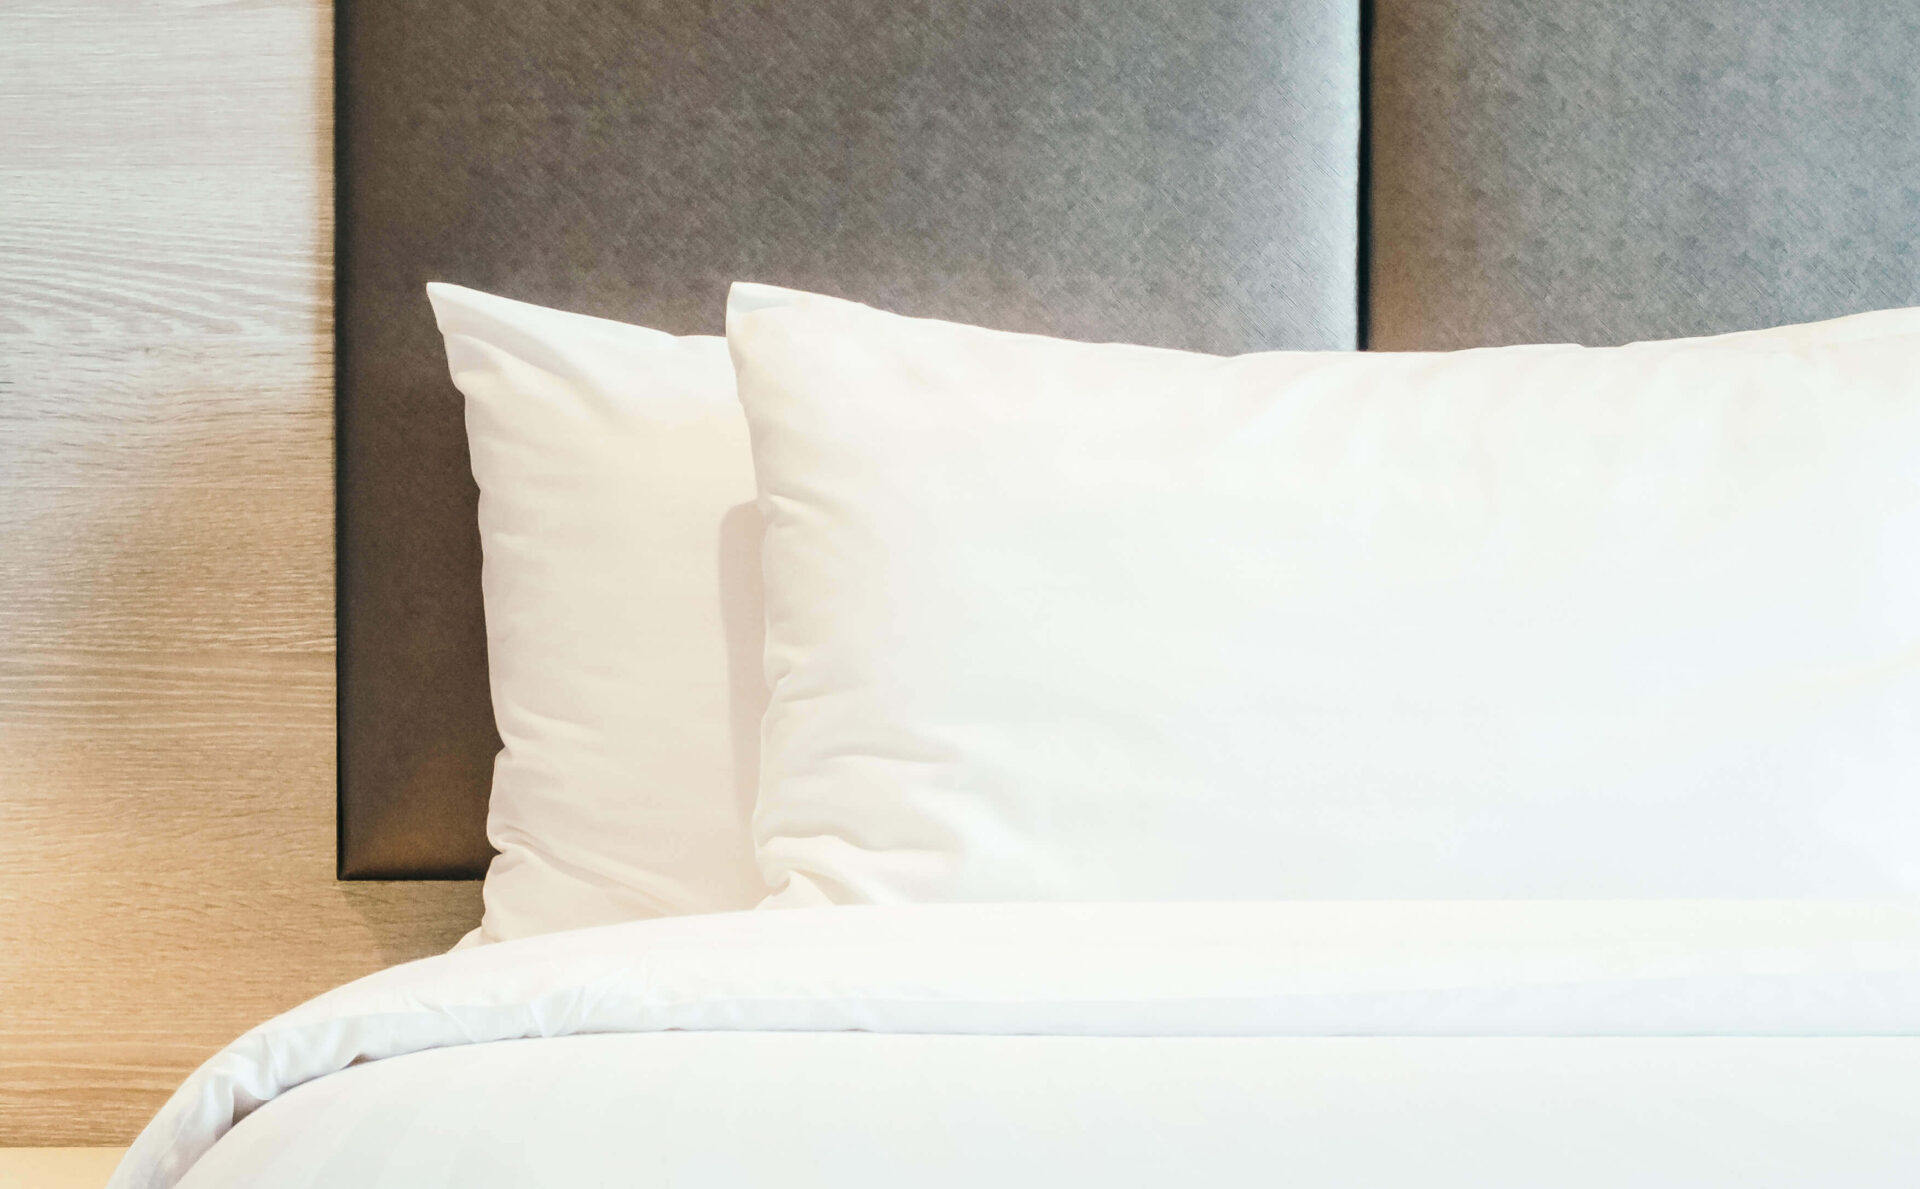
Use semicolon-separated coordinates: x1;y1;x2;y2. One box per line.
426;284;766;941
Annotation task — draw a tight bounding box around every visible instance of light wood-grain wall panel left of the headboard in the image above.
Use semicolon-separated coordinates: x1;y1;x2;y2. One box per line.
0;0;478;1147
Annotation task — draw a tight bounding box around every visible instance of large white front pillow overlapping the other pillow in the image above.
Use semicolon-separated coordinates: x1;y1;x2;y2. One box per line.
728;286;1920;905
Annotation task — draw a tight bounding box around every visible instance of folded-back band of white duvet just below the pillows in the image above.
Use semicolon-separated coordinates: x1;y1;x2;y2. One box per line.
111;901;1920;1189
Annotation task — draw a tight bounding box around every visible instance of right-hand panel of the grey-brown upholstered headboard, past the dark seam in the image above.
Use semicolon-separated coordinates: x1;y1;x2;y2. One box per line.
1367;0;1920;350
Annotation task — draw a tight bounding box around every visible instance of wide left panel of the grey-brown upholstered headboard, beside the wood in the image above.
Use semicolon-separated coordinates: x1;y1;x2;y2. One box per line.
338;0;1361;878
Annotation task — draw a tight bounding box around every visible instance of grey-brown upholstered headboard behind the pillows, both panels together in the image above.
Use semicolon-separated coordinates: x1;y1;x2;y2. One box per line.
338;0;1920;878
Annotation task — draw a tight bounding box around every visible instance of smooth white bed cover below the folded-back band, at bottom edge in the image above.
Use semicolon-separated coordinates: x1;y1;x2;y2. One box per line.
180;1031;1920;1189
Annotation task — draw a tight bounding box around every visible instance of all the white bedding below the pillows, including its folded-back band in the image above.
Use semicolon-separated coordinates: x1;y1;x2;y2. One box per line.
113;901;1920;1189
